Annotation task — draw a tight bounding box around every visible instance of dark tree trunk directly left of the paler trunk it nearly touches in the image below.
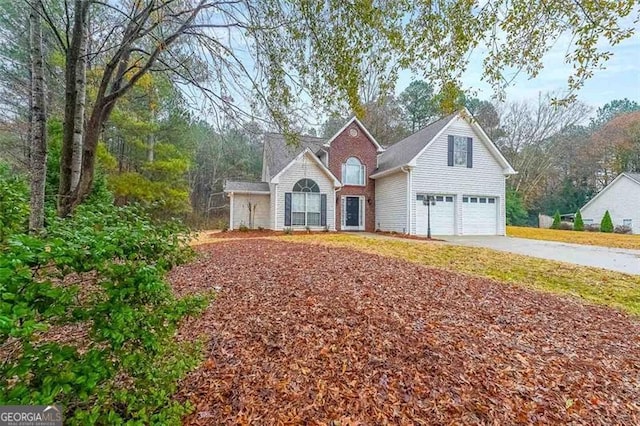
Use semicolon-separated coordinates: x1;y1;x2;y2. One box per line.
58;0;89;217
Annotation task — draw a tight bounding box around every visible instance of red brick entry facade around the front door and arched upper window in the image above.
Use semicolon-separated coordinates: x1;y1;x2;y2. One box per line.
328;121;378;232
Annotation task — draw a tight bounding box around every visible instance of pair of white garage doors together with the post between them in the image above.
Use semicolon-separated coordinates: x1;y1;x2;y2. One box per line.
415;194;499;235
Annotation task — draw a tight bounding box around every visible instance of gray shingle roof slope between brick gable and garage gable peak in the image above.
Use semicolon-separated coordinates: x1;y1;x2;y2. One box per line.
376;112;458;173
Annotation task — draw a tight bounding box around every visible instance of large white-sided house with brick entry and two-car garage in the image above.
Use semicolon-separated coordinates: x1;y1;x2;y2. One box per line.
224;110;515;235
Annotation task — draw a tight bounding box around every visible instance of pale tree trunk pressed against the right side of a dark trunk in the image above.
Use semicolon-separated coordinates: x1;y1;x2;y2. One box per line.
71;17;87;191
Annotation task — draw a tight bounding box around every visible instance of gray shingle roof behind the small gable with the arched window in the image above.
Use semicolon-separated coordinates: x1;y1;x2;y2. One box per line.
264;133;325;180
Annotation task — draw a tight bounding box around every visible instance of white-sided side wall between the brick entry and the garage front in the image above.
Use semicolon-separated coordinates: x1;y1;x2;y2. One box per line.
376;172;408;233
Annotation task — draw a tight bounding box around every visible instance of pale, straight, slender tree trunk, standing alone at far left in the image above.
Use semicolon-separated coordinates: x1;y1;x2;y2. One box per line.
29;0;47;232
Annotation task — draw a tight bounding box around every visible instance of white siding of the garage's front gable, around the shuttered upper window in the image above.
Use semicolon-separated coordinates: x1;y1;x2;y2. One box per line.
410;117;506;235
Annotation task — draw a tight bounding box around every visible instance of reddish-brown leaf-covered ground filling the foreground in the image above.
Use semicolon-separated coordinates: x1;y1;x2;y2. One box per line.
171;239;640;426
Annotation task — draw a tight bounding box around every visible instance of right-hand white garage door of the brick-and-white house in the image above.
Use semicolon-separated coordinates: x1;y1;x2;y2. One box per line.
462;195;498;235
